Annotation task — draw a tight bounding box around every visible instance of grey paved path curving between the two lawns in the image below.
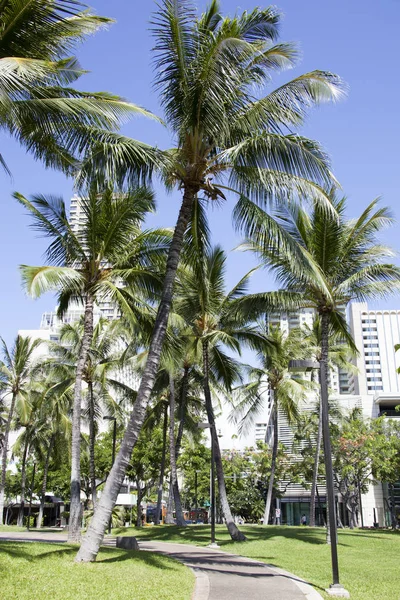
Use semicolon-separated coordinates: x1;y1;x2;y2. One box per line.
0;531;322;600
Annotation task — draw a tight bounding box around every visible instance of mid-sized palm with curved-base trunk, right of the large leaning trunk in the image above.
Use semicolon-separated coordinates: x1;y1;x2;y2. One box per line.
174;246;253;541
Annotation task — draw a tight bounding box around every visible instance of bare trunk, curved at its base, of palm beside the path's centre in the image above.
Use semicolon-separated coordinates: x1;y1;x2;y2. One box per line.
203;342;246;542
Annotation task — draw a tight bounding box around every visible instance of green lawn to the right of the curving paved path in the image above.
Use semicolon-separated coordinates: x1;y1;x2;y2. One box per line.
115;525;400;600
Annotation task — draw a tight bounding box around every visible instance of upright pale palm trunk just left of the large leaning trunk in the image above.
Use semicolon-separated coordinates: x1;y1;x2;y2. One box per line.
68;293;94;542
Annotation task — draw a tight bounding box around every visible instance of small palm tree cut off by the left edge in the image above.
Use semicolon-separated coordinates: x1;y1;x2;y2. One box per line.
0;335;41;525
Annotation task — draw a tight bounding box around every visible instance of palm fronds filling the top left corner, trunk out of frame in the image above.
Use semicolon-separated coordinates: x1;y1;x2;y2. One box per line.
0;0;156;173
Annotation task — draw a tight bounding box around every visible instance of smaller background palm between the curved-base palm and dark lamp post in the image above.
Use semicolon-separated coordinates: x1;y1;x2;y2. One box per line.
235;325;309;525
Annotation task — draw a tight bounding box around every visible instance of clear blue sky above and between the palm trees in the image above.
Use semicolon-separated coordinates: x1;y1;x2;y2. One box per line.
0;0;400;342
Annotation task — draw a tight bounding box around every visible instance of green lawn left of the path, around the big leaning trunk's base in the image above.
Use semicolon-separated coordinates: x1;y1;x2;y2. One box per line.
0;541;194;600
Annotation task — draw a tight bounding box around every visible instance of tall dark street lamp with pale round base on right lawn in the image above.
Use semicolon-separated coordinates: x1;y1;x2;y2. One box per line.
289;360;350;598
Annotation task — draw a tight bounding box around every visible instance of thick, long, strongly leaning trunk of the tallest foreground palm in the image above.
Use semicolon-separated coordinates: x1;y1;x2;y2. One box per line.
76;186;199;562
